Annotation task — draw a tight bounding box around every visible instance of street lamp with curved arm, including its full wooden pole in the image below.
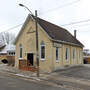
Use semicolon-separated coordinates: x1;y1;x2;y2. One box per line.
19;4;39;77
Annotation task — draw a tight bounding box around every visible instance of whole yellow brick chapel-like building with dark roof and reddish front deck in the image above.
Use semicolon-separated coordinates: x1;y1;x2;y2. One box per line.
15;15;83;72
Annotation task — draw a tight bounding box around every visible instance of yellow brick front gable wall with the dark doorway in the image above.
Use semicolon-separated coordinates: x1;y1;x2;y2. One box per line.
15;17;52;71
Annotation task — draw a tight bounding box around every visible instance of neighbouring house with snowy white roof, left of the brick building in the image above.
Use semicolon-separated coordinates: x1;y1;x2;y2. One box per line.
0;44;15;66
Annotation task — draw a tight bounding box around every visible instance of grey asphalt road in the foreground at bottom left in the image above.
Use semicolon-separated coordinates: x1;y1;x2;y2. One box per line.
0;72;67;90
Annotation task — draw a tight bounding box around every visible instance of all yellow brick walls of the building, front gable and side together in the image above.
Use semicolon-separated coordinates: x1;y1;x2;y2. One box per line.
15;16;82;72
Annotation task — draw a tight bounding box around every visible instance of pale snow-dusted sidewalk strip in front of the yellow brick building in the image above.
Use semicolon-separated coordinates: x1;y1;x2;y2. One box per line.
0;64;49;80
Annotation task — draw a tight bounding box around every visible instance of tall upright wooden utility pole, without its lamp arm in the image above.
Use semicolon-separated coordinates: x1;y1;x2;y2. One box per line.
35;10;39;77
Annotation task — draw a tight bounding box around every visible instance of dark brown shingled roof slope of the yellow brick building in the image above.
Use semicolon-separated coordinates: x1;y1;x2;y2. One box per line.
37;18;83;47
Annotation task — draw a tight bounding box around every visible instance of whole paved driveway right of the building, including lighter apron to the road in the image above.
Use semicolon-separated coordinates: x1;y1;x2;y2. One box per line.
45;65;90;90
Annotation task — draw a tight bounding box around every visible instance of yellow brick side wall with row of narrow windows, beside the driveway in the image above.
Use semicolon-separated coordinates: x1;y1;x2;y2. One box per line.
53;44;83;70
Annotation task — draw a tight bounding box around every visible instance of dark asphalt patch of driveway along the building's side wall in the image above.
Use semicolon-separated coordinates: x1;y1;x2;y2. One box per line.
53;64;90;80
